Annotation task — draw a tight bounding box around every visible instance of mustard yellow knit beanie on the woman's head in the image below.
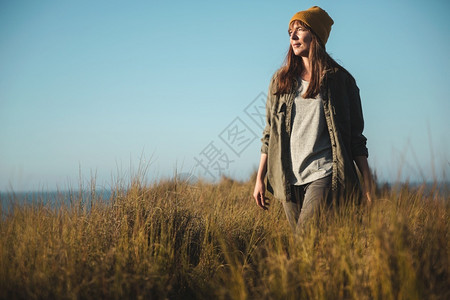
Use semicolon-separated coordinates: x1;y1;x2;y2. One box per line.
289;6;334;46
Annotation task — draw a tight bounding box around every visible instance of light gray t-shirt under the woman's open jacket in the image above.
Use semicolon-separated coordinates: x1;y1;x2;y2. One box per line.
290;80;333;185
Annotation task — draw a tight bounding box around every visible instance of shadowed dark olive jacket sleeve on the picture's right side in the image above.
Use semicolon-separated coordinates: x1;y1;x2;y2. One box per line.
347;76;369;158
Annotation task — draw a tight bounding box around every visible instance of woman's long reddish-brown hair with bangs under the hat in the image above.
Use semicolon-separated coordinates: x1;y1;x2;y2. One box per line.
275;20;342;98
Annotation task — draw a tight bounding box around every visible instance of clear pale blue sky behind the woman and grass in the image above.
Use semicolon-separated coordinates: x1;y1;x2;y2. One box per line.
0;0;450;191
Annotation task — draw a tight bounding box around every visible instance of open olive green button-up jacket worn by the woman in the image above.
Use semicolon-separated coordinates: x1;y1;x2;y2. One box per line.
261;68;368;201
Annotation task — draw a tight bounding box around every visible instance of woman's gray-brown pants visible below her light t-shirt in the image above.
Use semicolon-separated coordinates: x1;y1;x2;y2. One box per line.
283;175;331;233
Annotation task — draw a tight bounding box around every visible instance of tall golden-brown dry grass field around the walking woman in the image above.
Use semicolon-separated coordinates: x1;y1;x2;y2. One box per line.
0;178;450;299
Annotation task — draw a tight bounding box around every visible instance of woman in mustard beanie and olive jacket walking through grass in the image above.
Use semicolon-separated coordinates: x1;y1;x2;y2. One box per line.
253;6;372;230
